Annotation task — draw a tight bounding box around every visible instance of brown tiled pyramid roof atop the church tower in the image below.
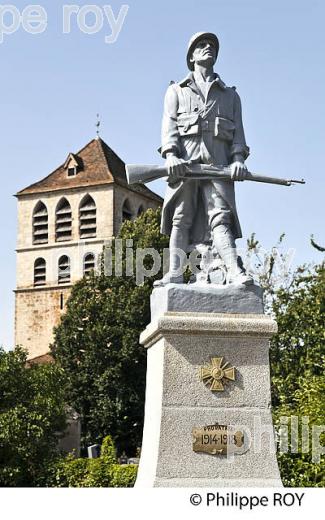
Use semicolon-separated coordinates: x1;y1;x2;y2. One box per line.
17;138;162;202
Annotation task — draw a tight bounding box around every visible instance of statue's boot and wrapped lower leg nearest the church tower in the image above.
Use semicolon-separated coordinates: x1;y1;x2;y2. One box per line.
153;226;189;287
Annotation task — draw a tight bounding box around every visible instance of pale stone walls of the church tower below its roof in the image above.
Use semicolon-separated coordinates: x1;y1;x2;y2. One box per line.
15;184;159;359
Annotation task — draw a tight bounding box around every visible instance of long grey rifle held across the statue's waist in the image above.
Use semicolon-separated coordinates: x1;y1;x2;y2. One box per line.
125;162;305;186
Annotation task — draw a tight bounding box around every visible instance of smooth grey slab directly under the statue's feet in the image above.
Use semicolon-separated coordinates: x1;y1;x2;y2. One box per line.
151;284;264;320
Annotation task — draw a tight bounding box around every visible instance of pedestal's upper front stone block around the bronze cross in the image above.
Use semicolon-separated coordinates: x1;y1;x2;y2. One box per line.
163;334;270;409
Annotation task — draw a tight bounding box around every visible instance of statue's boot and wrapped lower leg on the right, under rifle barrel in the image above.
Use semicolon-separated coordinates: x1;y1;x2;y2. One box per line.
212;224;254;285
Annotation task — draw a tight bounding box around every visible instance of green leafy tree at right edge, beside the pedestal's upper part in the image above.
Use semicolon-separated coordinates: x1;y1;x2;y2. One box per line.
270;263;325;405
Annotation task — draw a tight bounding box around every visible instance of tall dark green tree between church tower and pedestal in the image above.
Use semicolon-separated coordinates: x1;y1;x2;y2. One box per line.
52;210;168;455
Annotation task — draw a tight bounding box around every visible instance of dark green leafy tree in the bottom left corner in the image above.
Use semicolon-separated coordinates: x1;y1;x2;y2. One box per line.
0;347;66;487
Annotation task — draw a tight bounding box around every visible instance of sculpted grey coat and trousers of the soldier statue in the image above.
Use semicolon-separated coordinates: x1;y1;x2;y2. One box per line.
160;73;249;248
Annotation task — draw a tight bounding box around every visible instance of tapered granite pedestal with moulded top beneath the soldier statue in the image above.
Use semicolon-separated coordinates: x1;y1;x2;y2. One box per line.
136;284;281;487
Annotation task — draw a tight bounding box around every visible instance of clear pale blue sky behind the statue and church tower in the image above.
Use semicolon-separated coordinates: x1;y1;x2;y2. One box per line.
0;0;325;347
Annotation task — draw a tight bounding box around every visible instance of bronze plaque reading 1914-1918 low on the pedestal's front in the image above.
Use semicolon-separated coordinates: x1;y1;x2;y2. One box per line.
192;424;244;455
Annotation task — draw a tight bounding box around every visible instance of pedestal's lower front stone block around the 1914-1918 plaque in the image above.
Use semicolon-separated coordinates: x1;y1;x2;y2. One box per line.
156;407;279;480
